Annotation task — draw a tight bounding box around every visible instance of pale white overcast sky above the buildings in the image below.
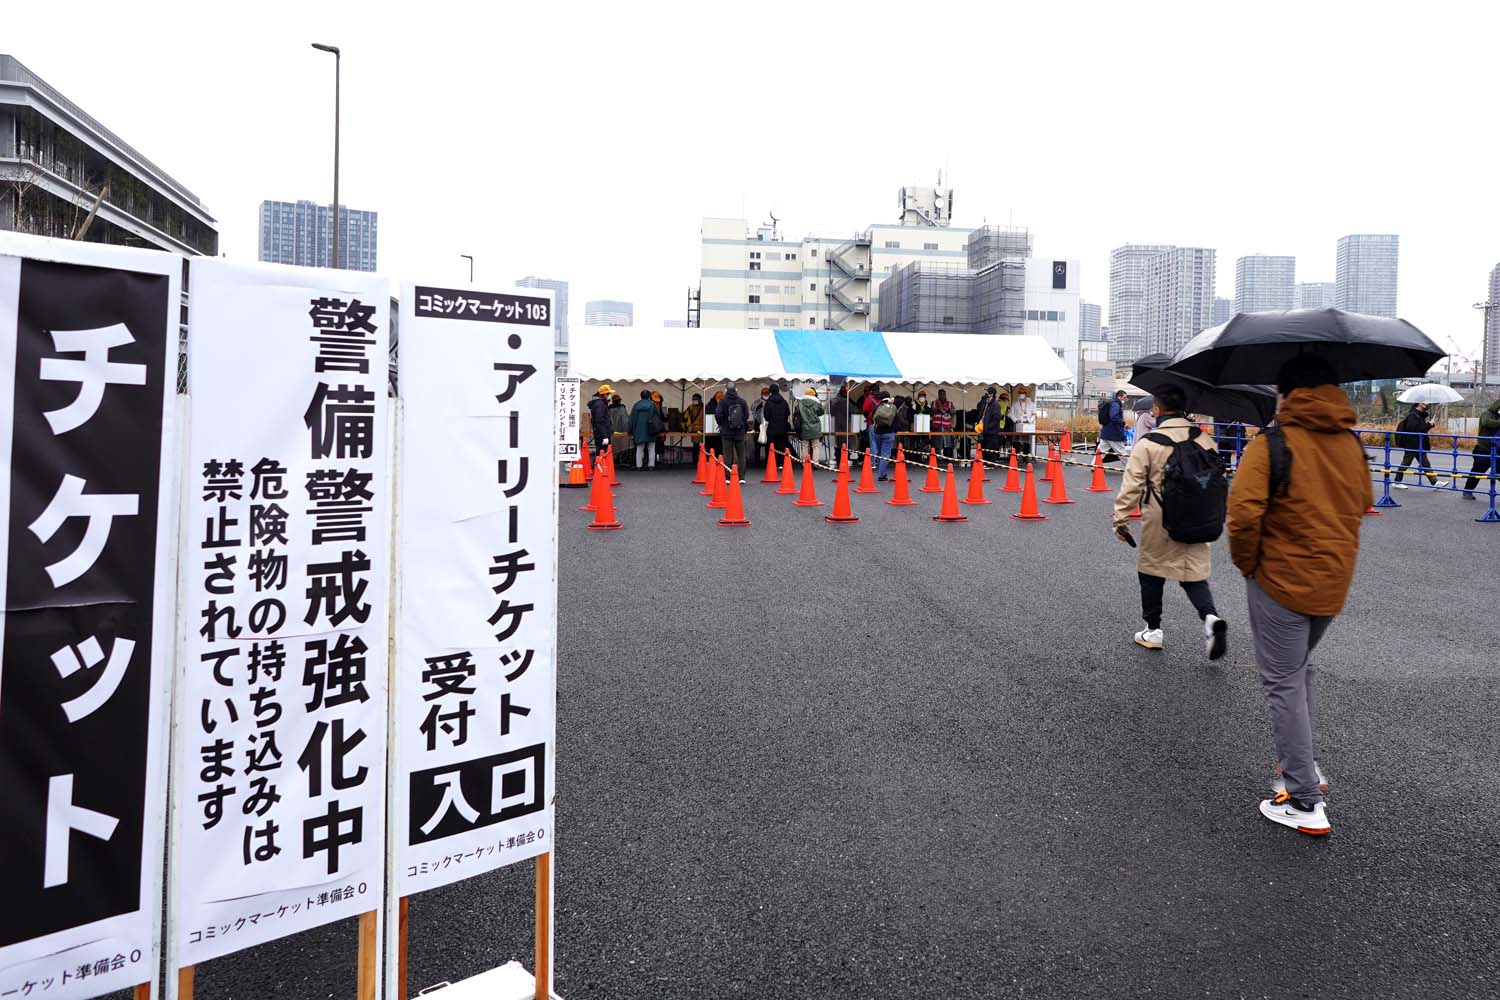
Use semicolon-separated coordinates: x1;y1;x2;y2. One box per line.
11;0;1500;364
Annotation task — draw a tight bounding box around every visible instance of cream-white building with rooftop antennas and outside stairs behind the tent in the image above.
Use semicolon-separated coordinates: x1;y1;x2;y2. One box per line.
699;187;971;330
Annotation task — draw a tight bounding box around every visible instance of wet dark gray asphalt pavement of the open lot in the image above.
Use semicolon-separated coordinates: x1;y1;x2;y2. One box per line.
187;455;1500;1000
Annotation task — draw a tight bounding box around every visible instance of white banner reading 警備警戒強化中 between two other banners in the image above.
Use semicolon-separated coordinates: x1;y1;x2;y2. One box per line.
170;261;390;975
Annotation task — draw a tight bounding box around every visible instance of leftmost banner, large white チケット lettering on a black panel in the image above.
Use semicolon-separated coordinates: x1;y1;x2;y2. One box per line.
0;232;182;1000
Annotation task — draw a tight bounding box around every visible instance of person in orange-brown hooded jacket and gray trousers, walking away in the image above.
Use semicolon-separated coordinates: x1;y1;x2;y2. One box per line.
1229;354;1373;835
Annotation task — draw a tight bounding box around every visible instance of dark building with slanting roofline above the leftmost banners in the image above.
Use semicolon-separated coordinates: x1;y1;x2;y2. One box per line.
0;55;219;256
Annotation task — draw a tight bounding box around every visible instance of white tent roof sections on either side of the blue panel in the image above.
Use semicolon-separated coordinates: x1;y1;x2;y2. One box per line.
569;327;1073;385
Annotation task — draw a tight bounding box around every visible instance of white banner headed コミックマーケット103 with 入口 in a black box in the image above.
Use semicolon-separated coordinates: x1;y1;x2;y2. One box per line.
390;285;558;895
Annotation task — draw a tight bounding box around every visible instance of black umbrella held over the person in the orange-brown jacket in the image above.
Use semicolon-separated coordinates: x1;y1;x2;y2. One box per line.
1172;309;1446;385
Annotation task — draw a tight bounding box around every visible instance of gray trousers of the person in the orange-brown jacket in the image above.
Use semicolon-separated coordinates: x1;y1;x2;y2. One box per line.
1245;579;1334;805
